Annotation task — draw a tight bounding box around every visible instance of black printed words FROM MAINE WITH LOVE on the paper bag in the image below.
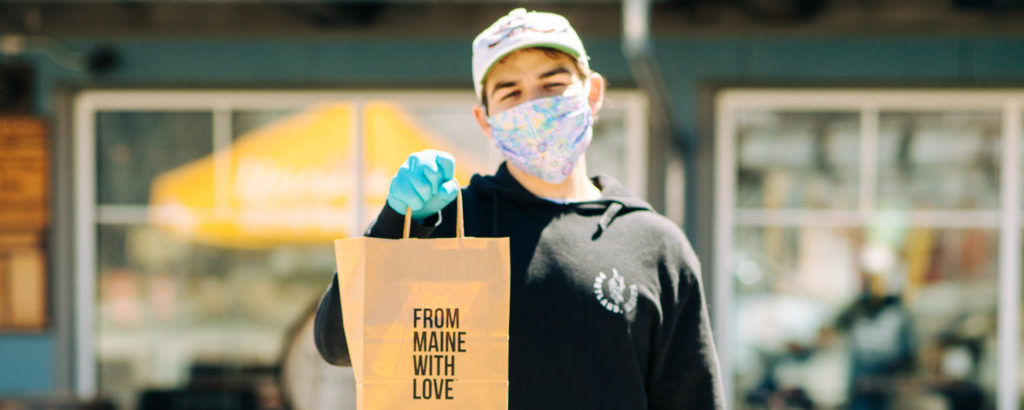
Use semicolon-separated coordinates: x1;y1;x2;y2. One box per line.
413;308;466;400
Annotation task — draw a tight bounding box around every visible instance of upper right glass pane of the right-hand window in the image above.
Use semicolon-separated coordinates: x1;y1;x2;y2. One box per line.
879;112;1002;209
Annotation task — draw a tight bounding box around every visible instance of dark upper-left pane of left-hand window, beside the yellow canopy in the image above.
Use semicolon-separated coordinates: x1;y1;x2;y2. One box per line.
96;112;213;205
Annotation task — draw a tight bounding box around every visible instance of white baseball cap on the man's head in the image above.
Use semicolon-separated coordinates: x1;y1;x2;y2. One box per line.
473;8;590;100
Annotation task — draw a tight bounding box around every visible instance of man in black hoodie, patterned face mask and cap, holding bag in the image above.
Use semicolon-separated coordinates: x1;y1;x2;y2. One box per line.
315;9;724;410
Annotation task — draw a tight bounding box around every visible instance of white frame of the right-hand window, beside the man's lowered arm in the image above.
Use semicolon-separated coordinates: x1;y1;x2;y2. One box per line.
713;88;1024;410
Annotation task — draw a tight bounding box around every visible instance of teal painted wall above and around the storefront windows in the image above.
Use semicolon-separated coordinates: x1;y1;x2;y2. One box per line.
0;32;1024;396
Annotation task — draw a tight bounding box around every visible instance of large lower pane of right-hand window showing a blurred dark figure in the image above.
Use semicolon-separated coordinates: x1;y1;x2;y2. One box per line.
733;223;998;409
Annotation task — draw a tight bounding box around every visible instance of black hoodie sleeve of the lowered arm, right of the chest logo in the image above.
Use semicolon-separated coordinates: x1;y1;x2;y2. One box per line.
648;233;725;410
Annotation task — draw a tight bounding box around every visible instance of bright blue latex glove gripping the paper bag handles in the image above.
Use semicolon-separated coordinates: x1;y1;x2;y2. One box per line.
387;150;459;222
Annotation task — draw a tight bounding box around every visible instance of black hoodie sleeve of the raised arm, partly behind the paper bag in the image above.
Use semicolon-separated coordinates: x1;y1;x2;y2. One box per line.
313;205;439;366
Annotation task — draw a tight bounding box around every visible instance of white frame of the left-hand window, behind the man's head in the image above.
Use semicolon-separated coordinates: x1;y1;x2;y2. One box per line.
72;89;648;398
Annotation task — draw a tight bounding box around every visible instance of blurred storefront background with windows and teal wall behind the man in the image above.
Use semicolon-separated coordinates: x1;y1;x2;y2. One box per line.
0;0;1024;410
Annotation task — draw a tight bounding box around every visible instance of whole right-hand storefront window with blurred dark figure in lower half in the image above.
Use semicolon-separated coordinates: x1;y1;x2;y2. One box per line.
716;91;1020;409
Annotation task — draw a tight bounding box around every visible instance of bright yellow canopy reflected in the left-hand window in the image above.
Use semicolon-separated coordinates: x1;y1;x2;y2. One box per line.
150;101;484;247
